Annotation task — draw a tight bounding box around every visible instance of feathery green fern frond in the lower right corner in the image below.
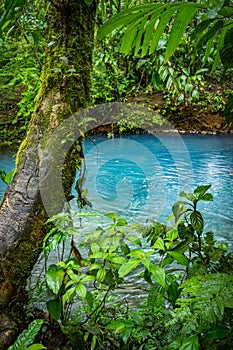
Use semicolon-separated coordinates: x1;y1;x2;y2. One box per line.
176;273;233;332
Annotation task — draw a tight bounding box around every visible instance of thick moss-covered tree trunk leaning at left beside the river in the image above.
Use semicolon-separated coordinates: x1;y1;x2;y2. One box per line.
0;0;96;349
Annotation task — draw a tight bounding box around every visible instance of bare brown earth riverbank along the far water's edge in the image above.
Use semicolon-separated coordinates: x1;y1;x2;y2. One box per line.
0;90;233;149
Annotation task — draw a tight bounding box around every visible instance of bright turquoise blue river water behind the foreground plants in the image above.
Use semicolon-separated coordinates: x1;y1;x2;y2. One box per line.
0;135;233;244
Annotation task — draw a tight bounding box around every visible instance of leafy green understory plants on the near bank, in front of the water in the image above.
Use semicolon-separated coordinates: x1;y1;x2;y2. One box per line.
27;185;233;350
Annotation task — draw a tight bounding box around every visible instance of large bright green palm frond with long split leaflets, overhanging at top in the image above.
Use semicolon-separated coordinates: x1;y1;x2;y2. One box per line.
98;2;206;60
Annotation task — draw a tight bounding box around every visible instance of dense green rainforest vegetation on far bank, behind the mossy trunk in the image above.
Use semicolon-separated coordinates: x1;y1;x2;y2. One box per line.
0;1;233;147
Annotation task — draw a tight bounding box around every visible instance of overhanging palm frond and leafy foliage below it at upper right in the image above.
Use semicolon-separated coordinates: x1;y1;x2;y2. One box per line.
98;1;233;123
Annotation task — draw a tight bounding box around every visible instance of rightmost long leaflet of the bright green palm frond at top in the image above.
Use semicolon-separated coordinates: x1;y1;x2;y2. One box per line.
164;3;198;62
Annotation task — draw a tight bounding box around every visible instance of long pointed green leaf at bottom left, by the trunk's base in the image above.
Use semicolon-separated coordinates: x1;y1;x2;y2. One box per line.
7;319;44;350
